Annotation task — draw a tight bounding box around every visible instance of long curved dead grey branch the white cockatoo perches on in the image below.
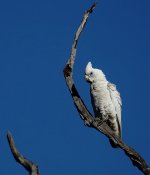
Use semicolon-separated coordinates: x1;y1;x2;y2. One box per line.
63;3;150;175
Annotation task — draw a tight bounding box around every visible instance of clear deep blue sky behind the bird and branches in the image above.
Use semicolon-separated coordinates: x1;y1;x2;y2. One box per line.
0;0;150;175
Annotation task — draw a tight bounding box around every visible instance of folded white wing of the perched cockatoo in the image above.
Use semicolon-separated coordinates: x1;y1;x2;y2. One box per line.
107;83;122;134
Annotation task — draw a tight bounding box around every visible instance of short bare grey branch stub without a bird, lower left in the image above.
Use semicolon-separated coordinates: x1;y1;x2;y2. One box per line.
7;132;40;175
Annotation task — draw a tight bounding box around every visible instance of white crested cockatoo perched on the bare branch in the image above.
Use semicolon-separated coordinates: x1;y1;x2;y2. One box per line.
85;62;122;148
